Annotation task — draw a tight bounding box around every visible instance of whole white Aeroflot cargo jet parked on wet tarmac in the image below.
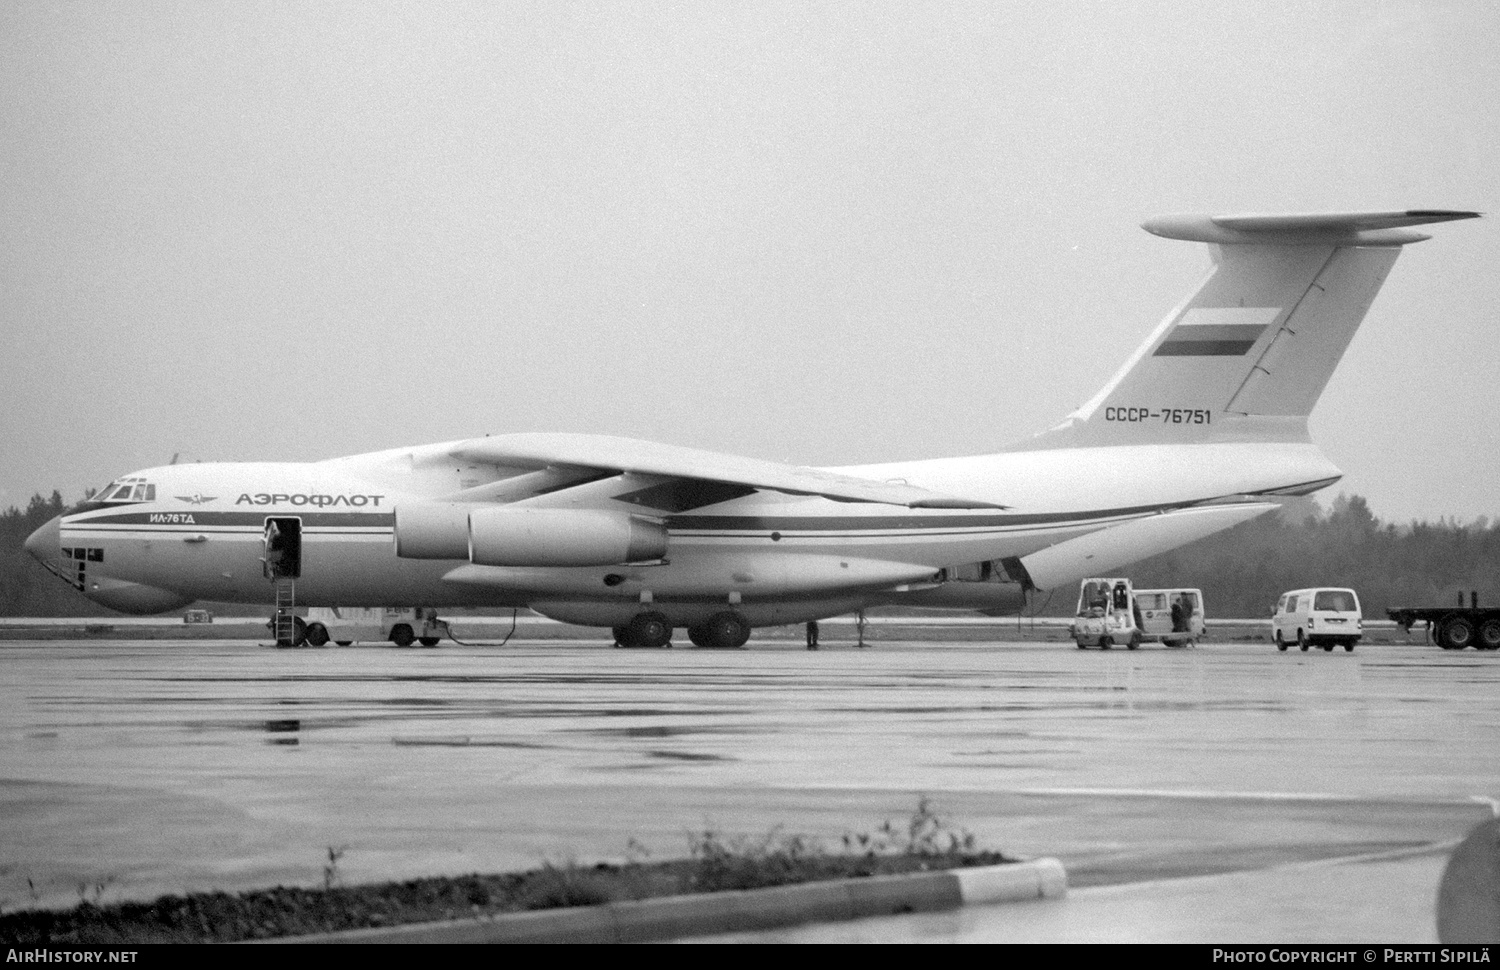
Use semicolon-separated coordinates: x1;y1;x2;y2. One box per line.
26;210;1478;646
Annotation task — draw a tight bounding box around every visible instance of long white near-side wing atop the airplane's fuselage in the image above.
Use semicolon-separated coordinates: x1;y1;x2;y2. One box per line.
450;433;1005;508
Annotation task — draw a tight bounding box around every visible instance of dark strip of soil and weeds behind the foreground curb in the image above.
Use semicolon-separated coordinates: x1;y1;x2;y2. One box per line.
0;798;1017;946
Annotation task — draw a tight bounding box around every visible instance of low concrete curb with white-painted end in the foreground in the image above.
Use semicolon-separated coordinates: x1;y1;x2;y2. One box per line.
266;859;1068;943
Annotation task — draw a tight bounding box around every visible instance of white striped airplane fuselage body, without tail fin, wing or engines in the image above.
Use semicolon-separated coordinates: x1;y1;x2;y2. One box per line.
41;442;1338;625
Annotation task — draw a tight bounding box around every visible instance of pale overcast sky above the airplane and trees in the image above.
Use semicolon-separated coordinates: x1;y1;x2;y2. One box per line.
0;0;1500;522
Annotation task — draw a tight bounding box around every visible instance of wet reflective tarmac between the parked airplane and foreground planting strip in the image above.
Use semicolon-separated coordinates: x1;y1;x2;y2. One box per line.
0;642;1500;906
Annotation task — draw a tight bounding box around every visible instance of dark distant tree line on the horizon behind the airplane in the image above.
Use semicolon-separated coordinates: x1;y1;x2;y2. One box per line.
0;492;1500;619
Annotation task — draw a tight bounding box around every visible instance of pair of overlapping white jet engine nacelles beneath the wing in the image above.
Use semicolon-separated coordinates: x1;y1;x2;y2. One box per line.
396;504;668;567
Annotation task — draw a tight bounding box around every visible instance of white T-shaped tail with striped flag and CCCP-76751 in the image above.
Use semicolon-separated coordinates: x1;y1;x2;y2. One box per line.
1013;210;1479;450
